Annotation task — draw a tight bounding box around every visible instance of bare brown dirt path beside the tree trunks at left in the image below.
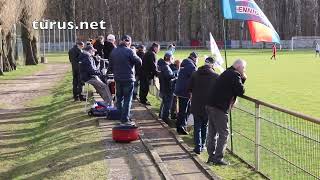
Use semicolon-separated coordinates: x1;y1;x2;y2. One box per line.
0;64;68;115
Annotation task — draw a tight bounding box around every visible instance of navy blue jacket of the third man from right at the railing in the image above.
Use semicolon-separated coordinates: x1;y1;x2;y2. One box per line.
174;58;197;98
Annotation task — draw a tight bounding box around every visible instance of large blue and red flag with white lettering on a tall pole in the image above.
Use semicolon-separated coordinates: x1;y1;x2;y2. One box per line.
222;0;280;44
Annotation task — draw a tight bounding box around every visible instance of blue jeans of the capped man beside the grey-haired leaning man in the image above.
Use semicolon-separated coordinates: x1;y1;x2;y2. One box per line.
193;114;208;151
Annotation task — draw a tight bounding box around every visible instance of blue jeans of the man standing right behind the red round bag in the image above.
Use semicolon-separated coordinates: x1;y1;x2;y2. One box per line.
116;81;134;123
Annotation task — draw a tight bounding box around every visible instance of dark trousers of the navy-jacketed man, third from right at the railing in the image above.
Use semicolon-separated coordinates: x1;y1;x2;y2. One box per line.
177;97;190;129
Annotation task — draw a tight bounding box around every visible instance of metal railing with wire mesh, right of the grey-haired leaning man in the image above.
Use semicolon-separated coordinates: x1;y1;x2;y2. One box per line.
150;83;320;180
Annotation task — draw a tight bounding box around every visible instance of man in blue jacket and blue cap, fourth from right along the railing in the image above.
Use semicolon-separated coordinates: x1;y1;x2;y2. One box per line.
158;52;176;122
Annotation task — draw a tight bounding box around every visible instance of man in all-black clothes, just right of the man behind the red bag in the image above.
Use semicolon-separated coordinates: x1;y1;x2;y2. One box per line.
139;43;160;105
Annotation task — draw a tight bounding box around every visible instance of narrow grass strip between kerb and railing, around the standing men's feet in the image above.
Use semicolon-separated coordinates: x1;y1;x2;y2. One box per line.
148;95;263;179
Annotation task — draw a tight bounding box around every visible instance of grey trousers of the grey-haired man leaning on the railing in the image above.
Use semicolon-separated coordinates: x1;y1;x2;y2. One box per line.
207;106;230;161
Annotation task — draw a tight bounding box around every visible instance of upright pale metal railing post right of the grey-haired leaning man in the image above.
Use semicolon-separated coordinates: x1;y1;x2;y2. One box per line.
255;103;261;171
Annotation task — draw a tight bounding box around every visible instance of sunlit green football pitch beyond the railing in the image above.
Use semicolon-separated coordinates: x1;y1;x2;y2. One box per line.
158;49;320;117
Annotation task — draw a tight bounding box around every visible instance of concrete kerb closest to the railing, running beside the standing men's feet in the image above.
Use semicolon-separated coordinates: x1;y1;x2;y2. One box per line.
145;106;221;180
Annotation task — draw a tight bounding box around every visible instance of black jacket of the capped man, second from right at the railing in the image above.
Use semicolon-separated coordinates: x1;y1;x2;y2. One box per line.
189;65;219;115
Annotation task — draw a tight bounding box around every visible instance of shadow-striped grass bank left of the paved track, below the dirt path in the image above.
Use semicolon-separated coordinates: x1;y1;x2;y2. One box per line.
0;75;107;179
